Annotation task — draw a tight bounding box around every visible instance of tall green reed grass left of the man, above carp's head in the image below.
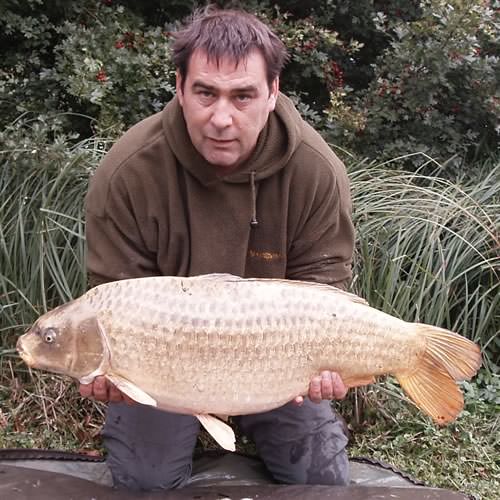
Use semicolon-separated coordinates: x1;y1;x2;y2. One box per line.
0;120;106;344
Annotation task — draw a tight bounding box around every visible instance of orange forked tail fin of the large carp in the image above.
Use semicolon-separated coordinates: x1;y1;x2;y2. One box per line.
395;323;481;425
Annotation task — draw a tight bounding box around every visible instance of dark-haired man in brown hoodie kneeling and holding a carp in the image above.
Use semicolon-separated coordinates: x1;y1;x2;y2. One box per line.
80;10;353;490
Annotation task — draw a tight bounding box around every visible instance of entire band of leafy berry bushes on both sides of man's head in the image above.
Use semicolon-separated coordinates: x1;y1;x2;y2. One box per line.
0;0;500;173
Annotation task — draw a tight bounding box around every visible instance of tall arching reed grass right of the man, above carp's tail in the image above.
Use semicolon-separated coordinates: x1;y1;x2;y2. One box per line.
350;156;500;367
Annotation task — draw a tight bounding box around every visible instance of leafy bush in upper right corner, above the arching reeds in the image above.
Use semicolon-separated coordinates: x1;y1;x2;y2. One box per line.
328;0;500;169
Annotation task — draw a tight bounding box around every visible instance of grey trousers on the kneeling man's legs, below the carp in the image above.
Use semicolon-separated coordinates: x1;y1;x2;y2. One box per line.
103;399;349;491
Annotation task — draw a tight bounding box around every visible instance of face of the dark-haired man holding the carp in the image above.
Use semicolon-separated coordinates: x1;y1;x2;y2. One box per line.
177;50;278;172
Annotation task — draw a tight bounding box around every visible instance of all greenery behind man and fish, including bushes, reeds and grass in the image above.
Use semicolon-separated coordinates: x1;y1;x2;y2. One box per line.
0;0;500;498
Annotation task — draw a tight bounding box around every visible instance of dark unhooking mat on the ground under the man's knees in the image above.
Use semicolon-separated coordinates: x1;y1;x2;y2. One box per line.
0;449;470;500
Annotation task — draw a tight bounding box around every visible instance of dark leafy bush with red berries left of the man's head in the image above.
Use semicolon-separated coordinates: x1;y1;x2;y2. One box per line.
0;1;175;136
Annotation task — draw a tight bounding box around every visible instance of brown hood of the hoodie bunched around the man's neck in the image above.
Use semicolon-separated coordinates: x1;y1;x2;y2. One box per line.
162;93;302;186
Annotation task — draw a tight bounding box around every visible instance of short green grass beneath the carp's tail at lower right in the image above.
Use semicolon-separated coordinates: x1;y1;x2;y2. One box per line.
344;378;500;500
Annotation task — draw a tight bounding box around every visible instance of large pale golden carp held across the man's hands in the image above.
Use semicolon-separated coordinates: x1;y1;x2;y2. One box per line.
17;274;481;449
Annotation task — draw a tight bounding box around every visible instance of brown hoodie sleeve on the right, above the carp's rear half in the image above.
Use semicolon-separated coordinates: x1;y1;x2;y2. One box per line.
287;146;354;289
